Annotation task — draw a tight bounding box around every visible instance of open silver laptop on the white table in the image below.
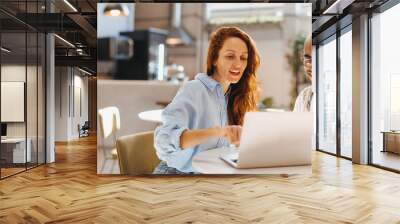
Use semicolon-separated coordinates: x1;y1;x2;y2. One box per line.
220;112;313;168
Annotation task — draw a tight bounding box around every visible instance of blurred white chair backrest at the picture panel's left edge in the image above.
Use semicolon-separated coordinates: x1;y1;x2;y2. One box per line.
99;107;121;139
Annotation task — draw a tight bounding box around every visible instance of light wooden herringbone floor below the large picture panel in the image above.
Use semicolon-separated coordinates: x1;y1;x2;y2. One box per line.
0;134;400;224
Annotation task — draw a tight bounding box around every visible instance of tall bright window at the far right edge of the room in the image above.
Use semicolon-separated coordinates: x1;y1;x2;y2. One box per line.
371;4;400;170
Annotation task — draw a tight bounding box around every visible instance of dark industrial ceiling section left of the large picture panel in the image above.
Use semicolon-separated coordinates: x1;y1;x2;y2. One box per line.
0;0;97;72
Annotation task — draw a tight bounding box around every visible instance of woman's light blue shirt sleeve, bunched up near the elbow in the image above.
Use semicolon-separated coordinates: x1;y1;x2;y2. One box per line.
154;86;196;161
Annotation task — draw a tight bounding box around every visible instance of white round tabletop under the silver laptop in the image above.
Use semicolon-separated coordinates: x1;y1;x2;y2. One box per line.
192;148;312;175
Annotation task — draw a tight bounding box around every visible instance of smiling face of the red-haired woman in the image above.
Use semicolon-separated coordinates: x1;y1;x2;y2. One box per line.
213;37;248;83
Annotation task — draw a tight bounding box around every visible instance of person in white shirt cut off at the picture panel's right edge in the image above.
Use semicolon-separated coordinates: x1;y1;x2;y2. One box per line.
293;36;314;112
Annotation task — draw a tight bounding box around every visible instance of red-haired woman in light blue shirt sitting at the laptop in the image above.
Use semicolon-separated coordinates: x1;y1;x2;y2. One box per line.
153;27;260;174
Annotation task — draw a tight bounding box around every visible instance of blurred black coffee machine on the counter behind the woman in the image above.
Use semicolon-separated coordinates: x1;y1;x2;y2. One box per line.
98;28;168;80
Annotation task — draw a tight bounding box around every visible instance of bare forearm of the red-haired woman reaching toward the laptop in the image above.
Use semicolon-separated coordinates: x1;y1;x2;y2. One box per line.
180;127;224;149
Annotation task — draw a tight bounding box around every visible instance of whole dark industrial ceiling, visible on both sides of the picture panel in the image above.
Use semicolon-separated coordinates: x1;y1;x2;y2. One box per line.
0;0;394;71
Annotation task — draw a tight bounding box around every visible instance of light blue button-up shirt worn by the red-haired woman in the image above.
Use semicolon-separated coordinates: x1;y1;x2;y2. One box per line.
154;74;229;172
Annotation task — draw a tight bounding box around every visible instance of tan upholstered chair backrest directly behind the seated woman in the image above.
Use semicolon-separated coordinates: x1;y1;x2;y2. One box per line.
117;131;160;175
